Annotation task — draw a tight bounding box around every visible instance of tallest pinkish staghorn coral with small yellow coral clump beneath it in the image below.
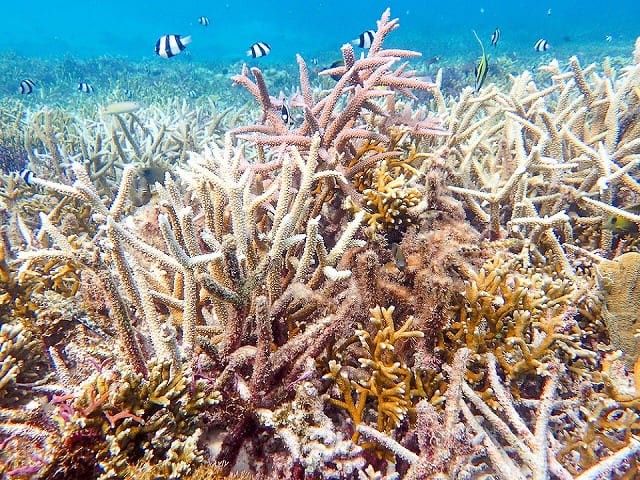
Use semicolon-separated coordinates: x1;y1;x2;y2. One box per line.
233;9;449;224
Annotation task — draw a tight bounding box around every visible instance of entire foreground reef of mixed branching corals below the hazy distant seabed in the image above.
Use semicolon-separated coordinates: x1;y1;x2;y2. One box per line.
0;10;640;480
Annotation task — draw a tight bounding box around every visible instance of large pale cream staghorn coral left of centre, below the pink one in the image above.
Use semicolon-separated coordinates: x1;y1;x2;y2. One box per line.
13;115;362;472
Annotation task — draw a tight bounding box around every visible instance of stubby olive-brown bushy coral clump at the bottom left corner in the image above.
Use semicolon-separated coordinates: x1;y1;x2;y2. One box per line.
43;361;220;479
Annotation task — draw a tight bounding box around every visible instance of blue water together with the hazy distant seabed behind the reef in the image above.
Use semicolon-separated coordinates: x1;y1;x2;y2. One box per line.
0;0;640;102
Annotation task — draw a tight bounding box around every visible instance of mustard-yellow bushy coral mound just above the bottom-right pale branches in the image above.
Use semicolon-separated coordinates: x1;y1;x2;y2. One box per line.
441;251;596;378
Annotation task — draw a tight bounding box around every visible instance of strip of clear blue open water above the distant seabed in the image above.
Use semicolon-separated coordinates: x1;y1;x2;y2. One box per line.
5;0;640;64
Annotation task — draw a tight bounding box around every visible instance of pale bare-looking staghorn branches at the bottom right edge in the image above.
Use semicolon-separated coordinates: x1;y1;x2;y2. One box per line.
358;349;640;480
